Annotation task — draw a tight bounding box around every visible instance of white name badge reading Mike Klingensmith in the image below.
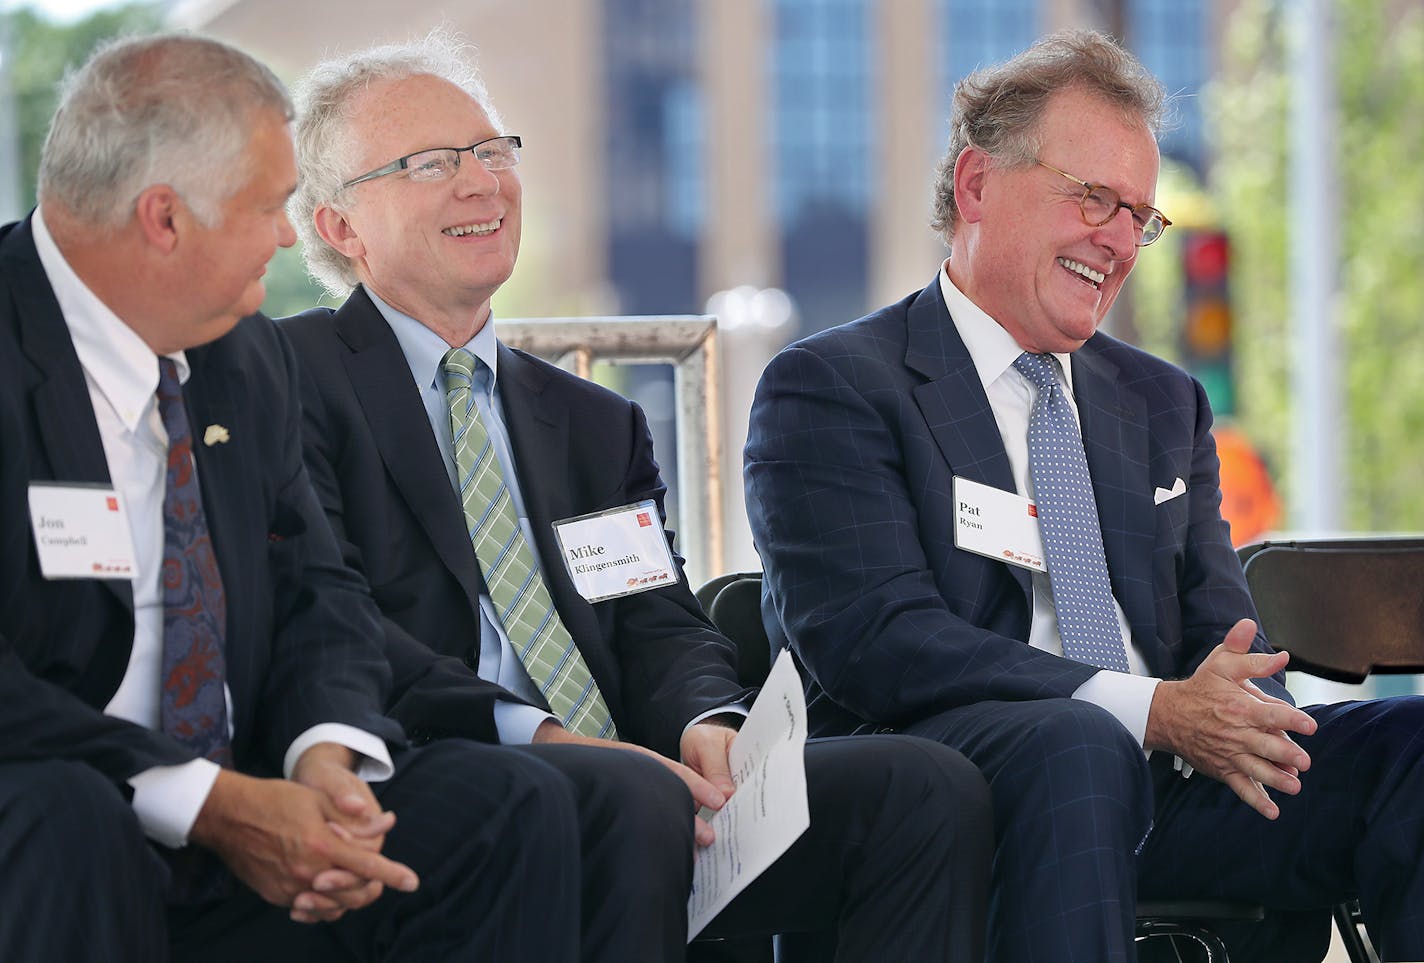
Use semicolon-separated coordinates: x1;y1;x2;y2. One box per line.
554;499;678;601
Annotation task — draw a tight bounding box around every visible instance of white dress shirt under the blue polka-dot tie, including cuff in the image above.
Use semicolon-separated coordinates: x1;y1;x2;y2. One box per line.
940;259;1161;745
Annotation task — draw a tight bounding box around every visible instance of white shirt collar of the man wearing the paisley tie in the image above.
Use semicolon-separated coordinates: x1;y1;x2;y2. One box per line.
31;208;189;432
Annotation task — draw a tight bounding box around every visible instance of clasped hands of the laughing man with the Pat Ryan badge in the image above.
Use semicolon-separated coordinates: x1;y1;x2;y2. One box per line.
1143;618;1316;819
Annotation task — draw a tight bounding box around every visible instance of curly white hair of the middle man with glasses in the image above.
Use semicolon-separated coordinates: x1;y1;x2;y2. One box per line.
288;28;503;298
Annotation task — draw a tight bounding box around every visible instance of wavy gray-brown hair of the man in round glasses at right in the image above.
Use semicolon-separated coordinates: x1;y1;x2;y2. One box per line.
930;30;1166;241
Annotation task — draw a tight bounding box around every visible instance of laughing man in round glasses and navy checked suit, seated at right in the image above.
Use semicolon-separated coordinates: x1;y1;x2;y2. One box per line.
745;31;1424;963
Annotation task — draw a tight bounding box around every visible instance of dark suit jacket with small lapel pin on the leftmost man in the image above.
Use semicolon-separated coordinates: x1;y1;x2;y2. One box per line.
0;221;403;793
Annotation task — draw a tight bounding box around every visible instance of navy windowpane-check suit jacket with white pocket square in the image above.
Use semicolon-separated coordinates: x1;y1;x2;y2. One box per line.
746;278;1284;734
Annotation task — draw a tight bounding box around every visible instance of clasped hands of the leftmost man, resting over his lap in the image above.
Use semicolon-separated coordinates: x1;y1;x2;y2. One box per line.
189;742;420;923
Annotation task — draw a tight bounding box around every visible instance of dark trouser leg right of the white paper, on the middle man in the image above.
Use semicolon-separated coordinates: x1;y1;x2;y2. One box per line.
705;735;993;963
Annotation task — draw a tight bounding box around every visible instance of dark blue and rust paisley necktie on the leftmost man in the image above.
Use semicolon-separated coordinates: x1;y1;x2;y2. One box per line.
158;358;232;766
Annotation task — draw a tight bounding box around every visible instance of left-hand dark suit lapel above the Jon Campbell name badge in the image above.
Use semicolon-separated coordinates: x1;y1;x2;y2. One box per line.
3;221;134;613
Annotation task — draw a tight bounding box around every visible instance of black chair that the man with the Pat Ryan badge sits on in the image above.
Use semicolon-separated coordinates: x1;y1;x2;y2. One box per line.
696;571;1263;963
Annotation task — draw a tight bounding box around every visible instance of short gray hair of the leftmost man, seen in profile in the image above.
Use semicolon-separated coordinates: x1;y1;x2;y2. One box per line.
38;33;292;229
